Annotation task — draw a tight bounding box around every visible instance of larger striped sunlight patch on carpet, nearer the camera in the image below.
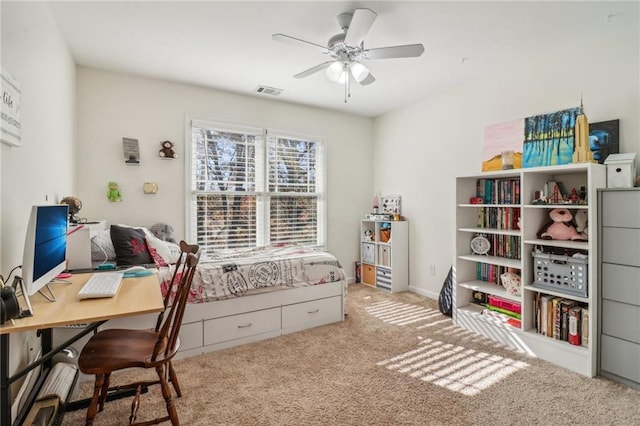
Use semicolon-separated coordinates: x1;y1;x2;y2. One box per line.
377;339;529;396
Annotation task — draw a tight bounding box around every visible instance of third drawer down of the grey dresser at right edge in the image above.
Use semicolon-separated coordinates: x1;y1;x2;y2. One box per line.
601;263;640;306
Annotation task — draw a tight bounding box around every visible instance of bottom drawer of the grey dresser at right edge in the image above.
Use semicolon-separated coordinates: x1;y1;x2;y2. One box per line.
600;336;640;383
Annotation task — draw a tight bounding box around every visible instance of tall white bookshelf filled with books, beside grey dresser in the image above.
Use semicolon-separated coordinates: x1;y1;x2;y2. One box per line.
453;163;606;377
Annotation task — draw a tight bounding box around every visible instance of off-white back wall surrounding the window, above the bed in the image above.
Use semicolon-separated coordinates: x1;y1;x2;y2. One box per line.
76;67;373;277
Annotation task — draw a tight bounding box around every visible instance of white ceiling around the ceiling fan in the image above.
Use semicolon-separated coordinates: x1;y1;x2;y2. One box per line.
48;1;638;117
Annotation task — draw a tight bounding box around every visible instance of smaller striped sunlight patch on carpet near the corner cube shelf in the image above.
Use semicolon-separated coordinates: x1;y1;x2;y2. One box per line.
365;301;442;328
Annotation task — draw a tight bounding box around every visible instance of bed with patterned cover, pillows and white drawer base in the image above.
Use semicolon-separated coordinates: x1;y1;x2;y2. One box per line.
92;225;347;357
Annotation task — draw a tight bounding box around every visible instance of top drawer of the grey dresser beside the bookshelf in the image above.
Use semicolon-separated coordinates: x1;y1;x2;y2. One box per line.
601;190;640;228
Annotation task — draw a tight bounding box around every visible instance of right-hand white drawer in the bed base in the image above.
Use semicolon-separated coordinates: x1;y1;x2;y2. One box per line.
282;296;342;332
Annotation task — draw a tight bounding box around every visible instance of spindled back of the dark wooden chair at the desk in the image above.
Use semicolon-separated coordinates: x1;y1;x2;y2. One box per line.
151;246;200;362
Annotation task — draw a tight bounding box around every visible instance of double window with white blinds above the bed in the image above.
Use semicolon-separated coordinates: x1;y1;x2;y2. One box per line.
187;121;325;251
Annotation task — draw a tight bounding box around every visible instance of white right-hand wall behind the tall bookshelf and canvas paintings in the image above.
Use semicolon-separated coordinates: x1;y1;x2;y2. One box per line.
374;17;640;297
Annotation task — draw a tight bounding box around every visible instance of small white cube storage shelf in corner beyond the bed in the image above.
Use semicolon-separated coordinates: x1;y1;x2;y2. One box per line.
360;219;409;293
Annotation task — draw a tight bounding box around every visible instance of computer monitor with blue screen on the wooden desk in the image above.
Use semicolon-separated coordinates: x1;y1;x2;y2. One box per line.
22;204;69;296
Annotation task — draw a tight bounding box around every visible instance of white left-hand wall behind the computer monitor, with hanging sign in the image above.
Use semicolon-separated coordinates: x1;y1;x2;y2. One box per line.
0;1;75;400
